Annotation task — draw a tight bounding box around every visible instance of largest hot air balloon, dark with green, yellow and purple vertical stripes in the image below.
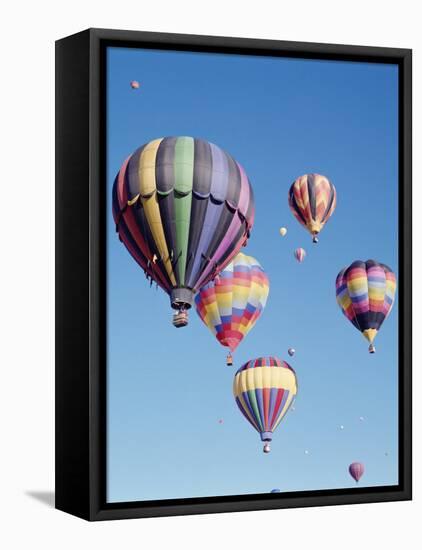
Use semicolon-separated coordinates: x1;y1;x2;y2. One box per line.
113;137;255;326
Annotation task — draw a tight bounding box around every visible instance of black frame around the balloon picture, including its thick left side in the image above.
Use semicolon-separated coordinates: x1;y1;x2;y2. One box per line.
56;29;412;521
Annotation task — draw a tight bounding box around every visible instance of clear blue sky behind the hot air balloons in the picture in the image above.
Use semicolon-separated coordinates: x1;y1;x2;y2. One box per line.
107;48;400;502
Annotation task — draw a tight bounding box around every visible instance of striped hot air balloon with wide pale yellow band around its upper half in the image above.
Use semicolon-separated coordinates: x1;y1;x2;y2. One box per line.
233;357;297;453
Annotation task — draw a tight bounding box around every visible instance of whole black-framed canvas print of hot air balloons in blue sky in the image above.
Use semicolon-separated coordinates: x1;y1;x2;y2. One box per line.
56;29;411;520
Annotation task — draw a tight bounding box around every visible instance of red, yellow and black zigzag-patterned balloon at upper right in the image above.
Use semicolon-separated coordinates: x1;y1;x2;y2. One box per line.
289;174;336;243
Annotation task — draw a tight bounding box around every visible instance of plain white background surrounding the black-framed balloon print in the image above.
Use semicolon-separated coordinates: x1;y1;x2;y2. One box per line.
0;0;416;550
